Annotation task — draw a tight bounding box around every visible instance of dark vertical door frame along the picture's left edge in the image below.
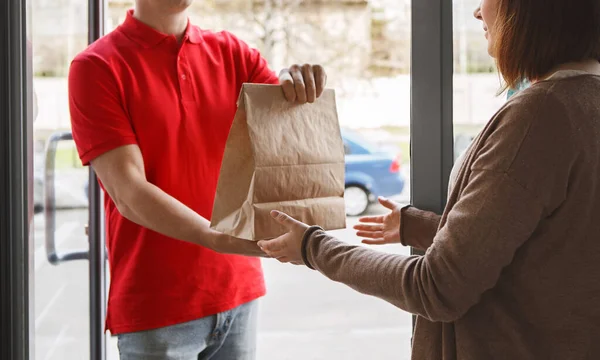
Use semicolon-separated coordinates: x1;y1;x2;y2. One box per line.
0;0;34;360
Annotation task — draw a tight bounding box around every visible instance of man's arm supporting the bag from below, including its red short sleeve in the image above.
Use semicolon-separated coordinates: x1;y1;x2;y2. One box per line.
69;57;264;256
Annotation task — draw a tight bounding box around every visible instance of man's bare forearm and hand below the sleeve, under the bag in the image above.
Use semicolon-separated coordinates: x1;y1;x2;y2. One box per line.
91;145;264;256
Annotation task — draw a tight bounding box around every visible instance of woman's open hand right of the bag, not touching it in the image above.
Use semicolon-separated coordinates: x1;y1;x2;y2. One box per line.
354;197;402;245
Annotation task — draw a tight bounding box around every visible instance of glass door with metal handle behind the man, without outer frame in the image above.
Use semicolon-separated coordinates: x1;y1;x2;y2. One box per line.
30;0;106;360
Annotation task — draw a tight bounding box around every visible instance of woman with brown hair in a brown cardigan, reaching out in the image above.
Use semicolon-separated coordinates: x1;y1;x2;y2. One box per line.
259;0;600;360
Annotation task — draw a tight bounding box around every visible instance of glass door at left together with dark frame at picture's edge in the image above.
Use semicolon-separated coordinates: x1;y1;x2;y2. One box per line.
0;0;105;360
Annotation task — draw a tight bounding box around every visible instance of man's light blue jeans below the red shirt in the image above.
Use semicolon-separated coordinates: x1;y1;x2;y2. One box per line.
118;301;258;360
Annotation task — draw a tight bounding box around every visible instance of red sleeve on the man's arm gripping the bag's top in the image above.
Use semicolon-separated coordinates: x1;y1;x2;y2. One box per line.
228;33;279;85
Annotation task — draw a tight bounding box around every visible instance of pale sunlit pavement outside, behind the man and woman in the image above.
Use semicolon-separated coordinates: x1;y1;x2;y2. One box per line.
34;206;411;360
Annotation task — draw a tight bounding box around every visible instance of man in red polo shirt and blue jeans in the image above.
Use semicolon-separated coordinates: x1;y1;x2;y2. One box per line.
69;0;326;360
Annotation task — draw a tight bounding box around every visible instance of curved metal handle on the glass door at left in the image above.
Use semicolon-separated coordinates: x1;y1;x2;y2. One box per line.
44;131;89;265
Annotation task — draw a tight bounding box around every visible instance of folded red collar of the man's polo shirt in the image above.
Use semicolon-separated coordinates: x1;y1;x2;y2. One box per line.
120;10;202;48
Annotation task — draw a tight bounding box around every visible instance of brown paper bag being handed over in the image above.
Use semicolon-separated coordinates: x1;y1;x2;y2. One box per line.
211;84;346;240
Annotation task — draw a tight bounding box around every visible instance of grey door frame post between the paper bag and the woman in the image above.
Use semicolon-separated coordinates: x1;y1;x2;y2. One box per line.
410;0;454;332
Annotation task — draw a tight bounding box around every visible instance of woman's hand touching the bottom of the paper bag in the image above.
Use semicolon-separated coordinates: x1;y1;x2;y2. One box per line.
258;210;309;265
